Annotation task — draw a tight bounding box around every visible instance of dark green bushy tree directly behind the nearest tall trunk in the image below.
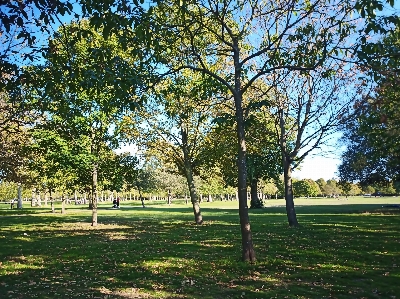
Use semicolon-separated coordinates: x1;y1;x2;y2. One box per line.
202;109;282;208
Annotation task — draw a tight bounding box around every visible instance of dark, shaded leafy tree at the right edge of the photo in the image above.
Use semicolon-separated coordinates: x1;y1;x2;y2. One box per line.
339;29;400;186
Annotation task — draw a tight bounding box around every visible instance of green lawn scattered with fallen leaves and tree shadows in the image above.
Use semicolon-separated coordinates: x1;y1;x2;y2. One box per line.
0;197;400;299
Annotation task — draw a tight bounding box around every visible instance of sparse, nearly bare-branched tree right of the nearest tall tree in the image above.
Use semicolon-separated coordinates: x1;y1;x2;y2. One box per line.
271;59;364;226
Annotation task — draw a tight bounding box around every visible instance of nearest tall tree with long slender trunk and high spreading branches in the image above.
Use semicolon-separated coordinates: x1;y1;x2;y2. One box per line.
145;0;368;261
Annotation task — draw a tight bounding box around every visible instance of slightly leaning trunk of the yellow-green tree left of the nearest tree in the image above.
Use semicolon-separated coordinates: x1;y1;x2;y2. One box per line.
181;124;203;224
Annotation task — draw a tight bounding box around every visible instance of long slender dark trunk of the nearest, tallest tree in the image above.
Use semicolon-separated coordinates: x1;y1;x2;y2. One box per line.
233;37;256;262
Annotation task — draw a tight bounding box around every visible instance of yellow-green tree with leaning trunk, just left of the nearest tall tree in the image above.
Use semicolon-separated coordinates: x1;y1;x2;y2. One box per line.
135;70;222;224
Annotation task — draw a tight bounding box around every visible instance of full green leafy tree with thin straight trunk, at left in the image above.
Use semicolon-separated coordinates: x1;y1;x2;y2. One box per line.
23;21;144;226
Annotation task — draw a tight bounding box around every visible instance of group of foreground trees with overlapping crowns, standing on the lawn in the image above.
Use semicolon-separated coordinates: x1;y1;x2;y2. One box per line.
1;0;398;261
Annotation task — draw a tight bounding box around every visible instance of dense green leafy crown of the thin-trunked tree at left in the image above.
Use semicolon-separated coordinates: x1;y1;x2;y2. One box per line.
20;21;144;197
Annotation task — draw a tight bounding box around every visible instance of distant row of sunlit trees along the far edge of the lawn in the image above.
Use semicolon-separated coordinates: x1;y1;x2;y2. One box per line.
0;173;399;208
